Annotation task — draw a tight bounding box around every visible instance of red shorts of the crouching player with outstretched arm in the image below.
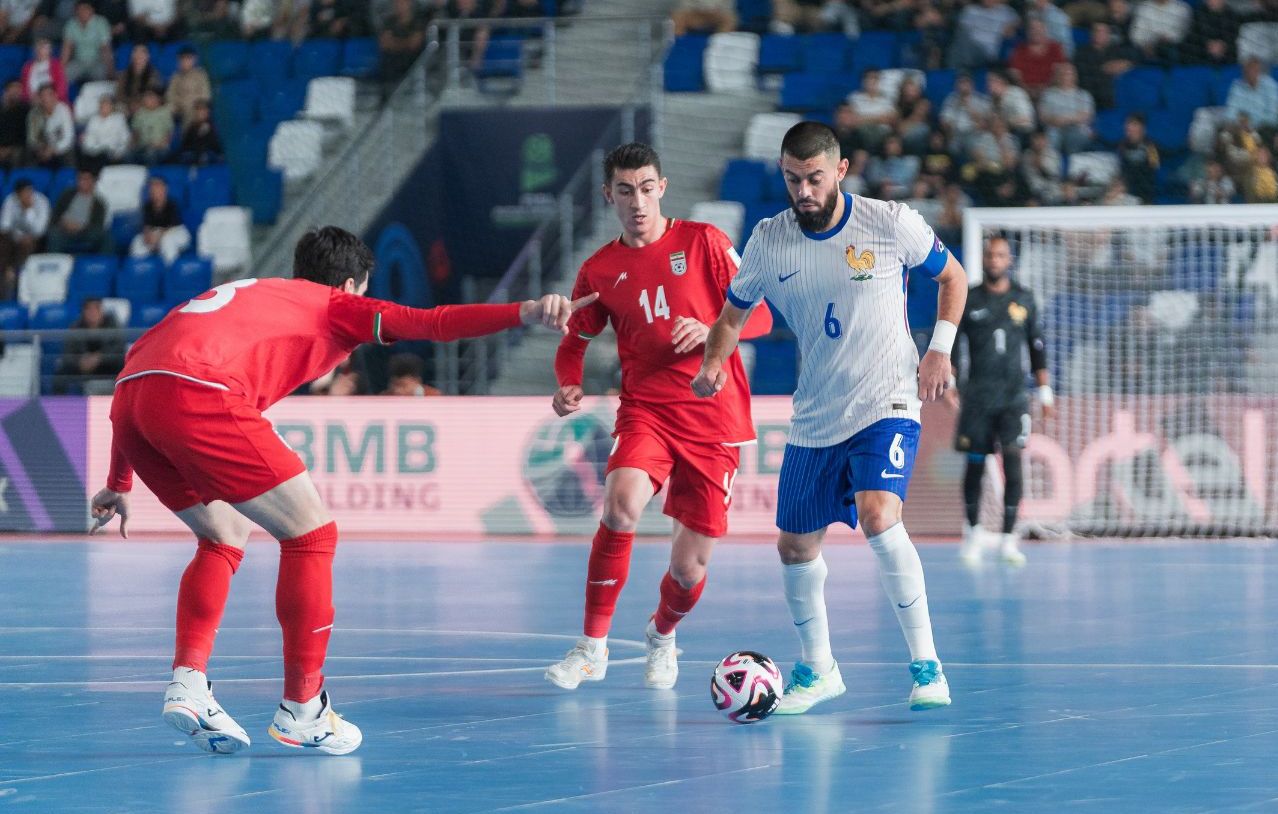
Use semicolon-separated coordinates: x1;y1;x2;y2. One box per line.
111;374;307;511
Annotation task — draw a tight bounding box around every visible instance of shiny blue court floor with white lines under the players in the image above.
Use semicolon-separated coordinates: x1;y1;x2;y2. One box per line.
0;539;1278;814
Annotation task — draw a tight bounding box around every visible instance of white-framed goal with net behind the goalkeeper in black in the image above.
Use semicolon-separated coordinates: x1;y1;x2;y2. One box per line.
964;206;1278;537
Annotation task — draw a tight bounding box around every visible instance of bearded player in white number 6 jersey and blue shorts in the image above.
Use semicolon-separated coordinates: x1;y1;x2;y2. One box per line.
693;121;967;714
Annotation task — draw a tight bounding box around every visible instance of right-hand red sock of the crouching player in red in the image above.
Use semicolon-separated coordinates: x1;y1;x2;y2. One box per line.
275;523;337;703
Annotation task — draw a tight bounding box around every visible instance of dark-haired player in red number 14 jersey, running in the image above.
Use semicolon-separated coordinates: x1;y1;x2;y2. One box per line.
546;144;772;690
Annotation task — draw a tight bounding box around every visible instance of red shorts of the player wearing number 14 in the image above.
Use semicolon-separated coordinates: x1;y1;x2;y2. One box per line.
607;422;741;538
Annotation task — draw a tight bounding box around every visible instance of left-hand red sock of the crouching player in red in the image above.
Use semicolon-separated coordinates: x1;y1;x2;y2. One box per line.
173;539;244;672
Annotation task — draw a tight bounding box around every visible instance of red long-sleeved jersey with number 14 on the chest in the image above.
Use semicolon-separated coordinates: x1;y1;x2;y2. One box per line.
555;219;772;443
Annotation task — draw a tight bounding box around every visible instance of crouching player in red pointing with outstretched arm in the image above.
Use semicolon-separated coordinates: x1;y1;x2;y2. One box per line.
92;226;594;754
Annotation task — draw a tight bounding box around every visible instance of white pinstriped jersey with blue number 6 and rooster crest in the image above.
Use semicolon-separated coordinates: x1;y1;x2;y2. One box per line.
728;193;948;447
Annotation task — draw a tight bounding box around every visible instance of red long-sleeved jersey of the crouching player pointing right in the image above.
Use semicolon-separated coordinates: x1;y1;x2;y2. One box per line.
119;279;520;410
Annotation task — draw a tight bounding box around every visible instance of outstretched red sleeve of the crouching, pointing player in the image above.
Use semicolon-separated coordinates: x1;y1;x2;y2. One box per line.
328;289;521;349
